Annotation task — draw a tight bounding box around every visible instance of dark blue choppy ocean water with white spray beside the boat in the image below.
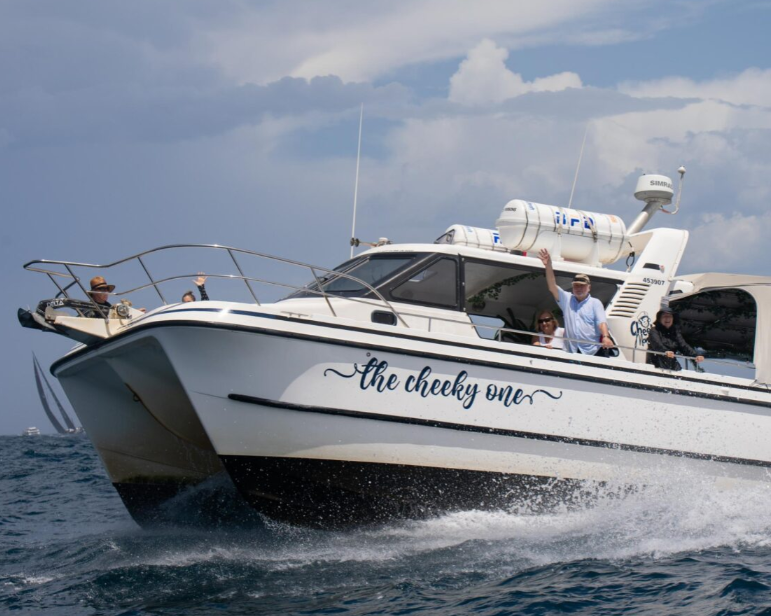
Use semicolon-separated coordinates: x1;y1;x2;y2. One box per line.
0;436;771;615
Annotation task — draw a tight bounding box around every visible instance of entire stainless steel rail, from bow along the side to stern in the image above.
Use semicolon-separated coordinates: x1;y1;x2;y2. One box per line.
24;244;740;369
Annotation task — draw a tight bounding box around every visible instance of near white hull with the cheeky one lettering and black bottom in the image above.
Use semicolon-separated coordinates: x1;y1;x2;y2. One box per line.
139;319;771;526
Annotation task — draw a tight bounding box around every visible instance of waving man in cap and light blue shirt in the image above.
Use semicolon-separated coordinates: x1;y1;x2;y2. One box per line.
538;248;613;355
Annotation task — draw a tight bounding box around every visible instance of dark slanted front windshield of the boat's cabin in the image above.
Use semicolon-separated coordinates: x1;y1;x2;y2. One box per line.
286;253;424;299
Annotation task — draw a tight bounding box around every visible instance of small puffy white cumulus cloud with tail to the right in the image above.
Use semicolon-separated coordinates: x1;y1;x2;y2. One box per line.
450;39;583;105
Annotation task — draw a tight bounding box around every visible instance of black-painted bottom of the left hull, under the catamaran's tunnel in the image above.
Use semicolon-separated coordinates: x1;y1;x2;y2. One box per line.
113;473;262;528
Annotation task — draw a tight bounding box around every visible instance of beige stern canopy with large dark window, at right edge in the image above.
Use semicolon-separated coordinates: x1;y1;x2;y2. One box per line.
668;274;771;384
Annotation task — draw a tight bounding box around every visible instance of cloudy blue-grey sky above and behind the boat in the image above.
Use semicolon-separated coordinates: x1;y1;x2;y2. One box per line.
0;0;771;434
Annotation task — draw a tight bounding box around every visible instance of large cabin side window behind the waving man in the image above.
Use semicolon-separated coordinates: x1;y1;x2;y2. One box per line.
463;259;618;344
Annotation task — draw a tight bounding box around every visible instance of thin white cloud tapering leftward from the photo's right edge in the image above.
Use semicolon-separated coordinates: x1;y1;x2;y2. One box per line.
618;68;771;107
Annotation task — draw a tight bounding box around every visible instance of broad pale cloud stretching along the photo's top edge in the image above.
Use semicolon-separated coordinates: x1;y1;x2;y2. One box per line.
200;0;669;83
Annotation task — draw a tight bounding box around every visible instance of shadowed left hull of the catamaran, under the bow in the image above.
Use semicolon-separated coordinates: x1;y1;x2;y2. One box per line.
55;337;241;527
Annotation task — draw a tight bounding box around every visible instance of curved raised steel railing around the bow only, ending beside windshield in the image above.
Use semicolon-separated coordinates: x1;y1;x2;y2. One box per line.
24;244;409;327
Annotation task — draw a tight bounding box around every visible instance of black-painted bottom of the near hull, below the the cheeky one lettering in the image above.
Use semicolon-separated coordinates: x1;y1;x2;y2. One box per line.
222;456;597;528
